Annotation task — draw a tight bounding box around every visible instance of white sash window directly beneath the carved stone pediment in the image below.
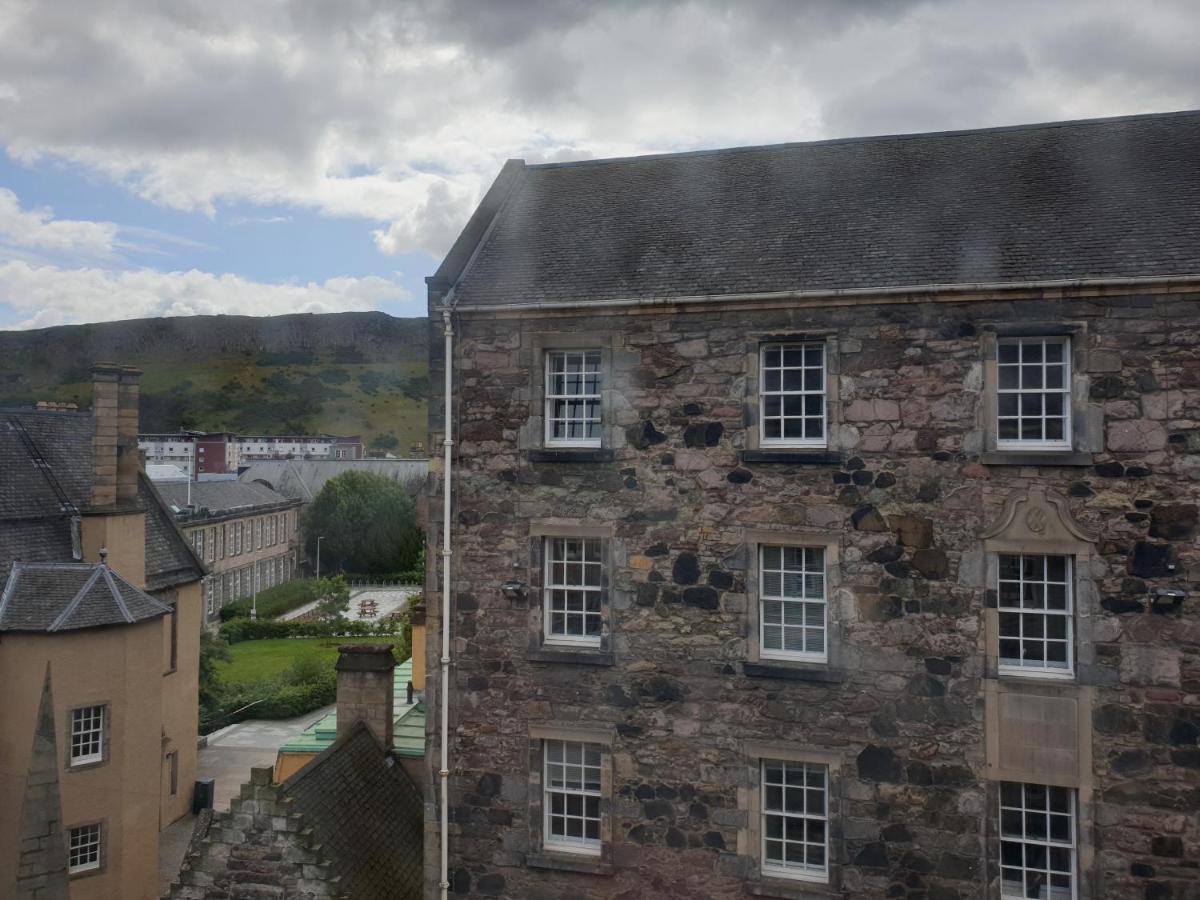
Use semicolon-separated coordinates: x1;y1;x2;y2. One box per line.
997;553;1074;676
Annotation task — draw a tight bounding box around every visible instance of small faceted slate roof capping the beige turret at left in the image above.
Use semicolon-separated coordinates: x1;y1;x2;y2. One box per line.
0;563;170;631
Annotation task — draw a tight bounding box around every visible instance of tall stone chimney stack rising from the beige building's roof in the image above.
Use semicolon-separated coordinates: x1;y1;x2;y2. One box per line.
91;362;142;509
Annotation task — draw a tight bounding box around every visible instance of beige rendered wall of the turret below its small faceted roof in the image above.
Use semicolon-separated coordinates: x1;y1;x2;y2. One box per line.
0;619;166;900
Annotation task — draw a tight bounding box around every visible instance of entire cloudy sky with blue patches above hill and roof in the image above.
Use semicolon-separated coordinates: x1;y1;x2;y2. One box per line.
0;0;1200;328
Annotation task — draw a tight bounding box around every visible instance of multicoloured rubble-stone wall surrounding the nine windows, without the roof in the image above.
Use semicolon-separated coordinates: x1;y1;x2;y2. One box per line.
426;294;1200;900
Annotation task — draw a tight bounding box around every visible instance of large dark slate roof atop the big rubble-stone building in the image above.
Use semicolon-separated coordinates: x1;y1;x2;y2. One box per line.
431;112;1200;307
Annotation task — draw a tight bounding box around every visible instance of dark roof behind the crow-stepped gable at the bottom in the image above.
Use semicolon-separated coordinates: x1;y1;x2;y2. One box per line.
283;722;424;900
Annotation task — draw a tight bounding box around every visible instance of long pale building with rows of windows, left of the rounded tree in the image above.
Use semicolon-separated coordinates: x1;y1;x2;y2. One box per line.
158;481;300;623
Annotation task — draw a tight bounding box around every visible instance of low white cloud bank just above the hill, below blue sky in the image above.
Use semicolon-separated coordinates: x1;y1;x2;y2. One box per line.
0;260;421;329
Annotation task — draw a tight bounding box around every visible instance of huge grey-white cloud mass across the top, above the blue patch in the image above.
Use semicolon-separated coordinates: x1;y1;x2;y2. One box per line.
0;0;1200;254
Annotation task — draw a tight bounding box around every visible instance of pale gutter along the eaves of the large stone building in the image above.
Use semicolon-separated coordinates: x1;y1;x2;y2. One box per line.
455;274;1200;316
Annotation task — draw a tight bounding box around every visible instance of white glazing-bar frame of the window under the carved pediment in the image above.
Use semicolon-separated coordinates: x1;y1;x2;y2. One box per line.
996;553;1075;678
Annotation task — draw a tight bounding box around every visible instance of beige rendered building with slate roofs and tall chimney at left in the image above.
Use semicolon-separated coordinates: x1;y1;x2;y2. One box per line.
0;366;204;900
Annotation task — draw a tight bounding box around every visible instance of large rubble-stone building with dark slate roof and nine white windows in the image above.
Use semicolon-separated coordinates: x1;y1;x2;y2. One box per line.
426;113;1200;900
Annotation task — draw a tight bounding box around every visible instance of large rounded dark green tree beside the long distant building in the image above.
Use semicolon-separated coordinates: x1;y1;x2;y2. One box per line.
304;470;425;575
